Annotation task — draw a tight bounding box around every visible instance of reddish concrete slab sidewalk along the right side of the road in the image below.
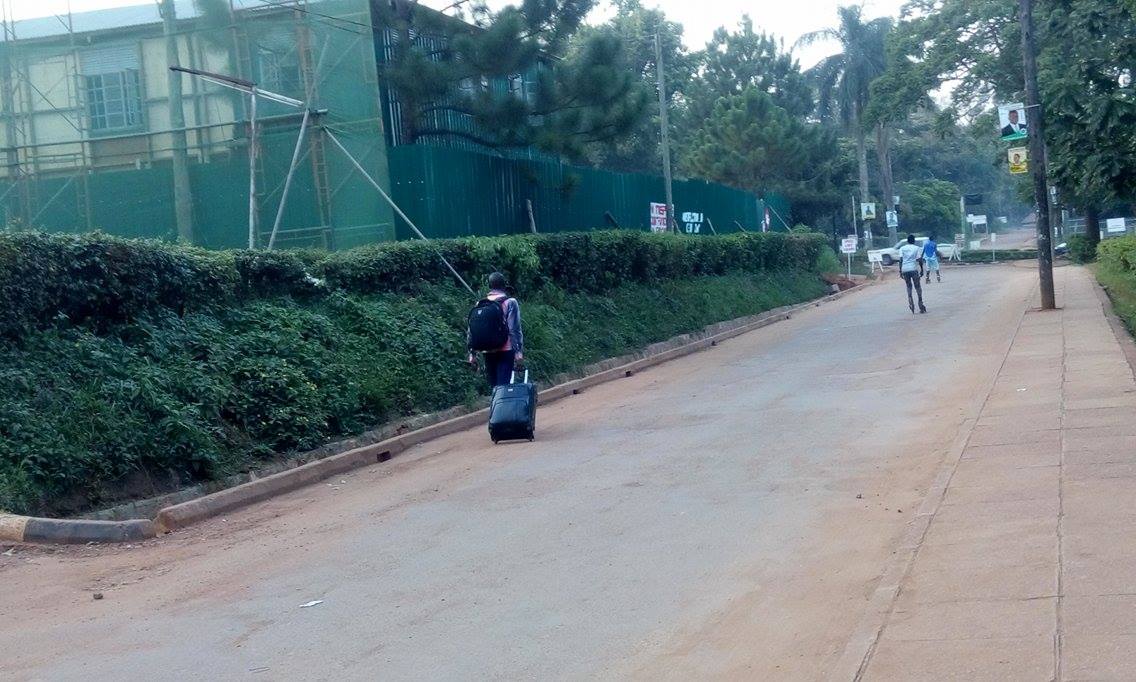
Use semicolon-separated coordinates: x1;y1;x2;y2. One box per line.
844;267;1136;680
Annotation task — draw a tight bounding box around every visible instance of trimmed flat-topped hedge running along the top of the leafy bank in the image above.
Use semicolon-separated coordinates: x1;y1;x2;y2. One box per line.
0;231;824;339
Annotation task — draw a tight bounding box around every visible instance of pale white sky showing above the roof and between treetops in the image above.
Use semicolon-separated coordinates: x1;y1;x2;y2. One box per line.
6;0;903;67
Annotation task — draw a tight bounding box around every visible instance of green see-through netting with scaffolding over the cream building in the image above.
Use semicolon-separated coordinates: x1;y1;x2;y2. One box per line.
0;0;394;248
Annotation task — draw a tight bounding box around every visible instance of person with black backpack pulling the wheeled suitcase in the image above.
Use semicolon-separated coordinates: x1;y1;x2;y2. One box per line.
467;273;525;390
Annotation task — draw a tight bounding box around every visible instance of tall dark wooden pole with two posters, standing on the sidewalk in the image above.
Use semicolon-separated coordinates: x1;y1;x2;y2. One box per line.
1020;0;1058;310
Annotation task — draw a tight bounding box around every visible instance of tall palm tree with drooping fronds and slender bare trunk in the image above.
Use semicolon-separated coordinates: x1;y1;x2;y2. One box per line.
796;6;892;234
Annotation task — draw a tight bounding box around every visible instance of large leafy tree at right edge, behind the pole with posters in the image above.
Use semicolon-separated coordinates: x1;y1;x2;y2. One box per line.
900;0;1136;239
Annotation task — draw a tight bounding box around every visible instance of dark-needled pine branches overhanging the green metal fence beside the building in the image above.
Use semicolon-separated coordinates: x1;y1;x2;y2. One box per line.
371;0;650;157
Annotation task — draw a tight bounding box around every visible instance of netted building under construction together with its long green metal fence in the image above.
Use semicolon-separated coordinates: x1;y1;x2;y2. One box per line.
0;0;787;248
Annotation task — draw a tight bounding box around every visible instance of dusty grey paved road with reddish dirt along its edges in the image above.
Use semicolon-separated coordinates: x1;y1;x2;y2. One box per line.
0;267;1035;680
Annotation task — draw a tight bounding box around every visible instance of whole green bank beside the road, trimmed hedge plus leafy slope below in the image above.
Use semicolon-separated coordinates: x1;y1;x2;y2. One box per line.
0;232;827;513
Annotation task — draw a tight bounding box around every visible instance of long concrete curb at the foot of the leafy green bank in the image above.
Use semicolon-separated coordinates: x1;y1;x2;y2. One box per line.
0;281;872;543
